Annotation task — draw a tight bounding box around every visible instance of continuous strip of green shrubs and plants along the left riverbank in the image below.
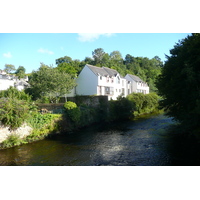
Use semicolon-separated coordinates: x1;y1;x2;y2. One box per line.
0;87;159;148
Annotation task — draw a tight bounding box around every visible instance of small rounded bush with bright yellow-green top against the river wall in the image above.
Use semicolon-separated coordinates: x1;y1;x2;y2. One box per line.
64;101;81;124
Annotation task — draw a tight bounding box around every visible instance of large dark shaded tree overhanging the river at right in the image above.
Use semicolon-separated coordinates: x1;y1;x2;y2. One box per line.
156;34;200;129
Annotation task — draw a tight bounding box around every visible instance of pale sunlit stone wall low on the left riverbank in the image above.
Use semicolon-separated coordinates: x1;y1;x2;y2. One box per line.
0;124;33;143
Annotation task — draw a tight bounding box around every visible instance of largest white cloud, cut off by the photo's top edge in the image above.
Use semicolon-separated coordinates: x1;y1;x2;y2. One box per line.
78;33;114;42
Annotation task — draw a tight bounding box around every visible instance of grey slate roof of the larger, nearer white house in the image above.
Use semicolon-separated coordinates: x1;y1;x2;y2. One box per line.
87;64;119;76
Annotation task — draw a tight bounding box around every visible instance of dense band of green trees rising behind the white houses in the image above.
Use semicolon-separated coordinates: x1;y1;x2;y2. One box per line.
56;48;163;92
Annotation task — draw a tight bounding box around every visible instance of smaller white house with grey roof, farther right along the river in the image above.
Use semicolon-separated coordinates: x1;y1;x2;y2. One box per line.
125;74;149;94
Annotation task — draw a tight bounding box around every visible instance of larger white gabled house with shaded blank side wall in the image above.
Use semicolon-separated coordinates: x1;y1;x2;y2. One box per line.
75;64;127;100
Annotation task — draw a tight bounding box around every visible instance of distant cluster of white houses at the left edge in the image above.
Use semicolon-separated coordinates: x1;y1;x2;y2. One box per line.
0;70;29;91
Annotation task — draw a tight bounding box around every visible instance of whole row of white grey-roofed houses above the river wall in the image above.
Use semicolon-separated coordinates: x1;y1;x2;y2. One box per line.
67;64;149;100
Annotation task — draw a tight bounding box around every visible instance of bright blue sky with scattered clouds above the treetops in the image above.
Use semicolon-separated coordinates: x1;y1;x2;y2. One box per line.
0;33;189;73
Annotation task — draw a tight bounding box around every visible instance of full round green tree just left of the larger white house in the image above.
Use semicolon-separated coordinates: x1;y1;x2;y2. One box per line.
27;63;76;102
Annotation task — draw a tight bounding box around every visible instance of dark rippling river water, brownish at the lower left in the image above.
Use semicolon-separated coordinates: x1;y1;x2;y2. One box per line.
0;114;200;166
